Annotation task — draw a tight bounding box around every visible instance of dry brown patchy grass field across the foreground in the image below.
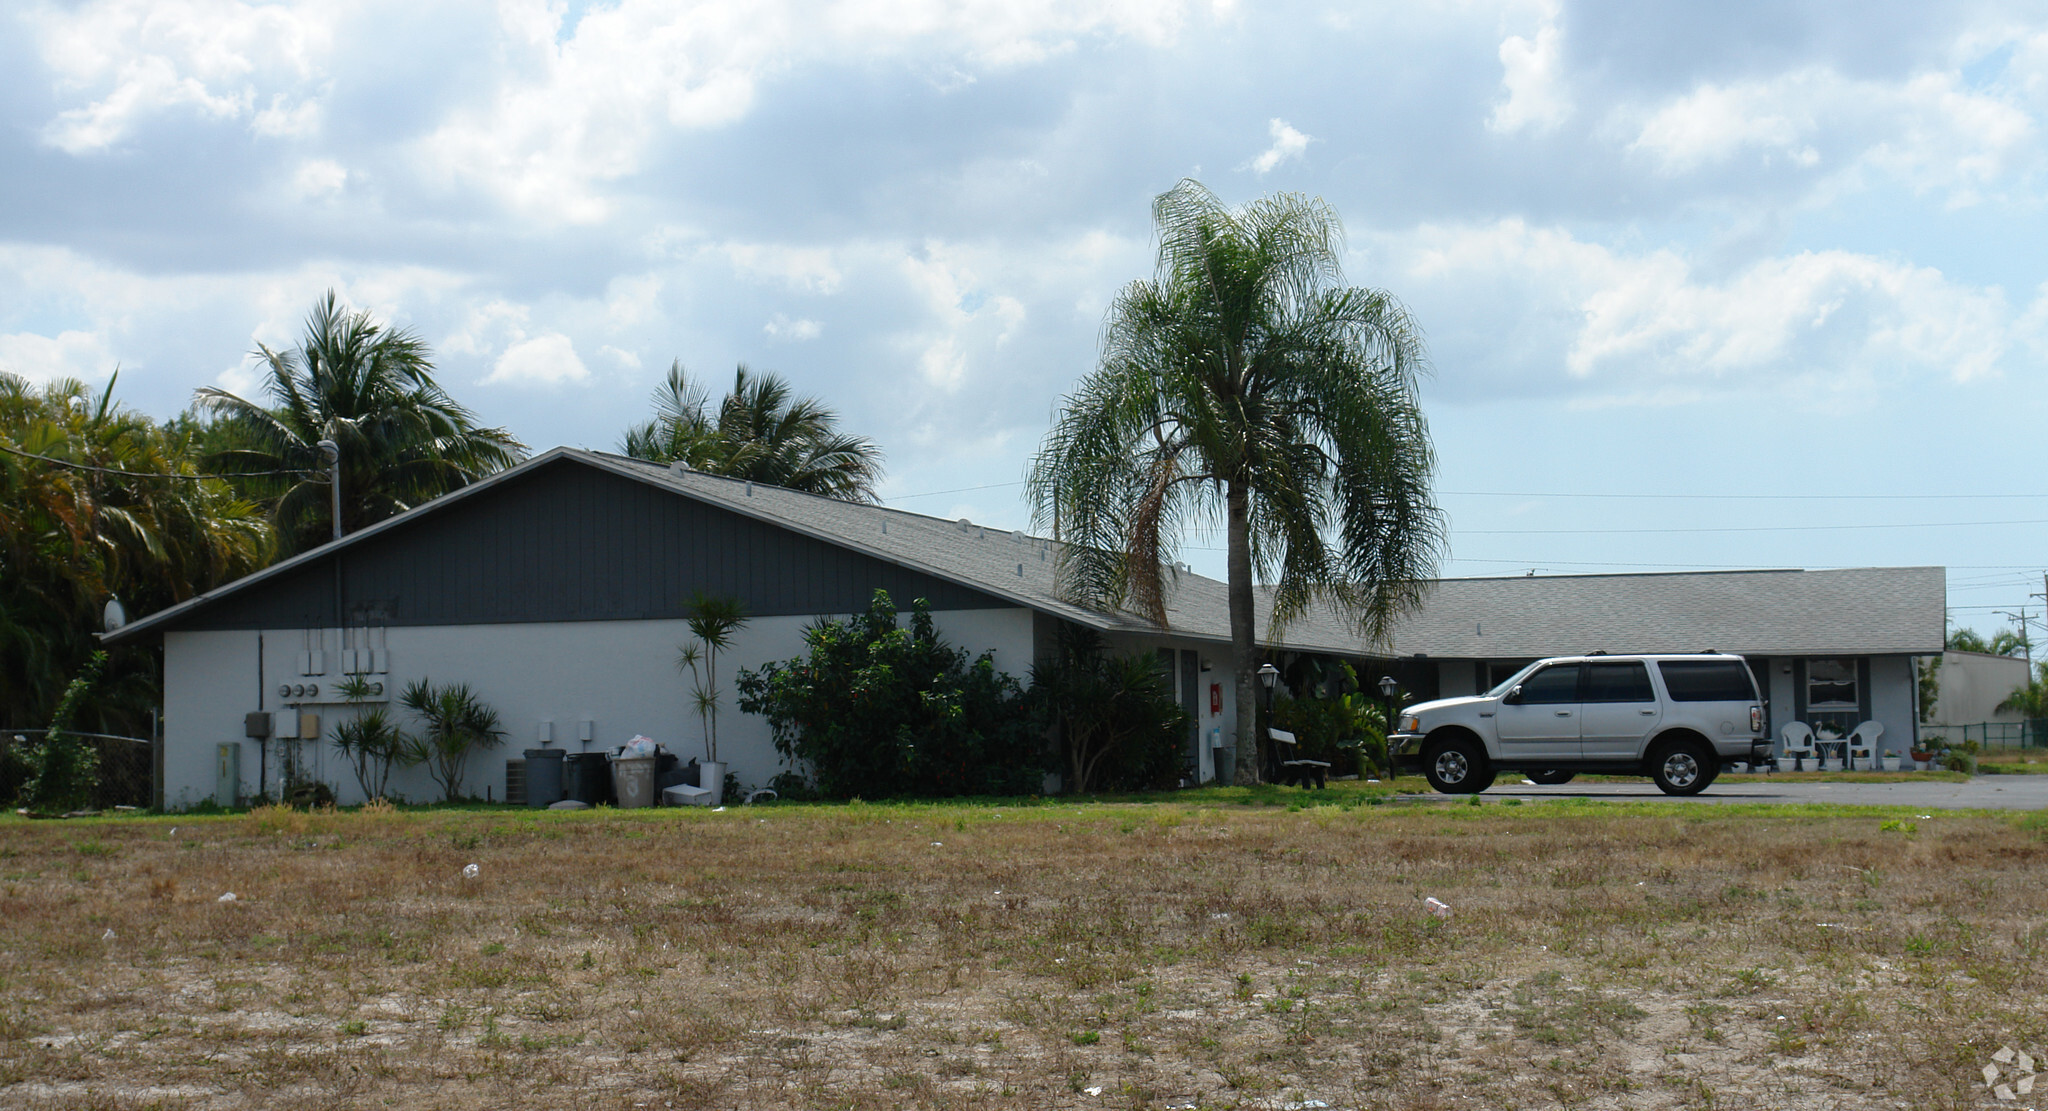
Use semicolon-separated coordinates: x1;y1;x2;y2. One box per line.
0;785;2048;1109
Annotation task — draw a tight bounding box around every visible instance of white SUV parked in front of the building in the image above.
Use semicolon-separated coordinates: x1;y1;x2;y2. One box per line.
1386;652;1772;795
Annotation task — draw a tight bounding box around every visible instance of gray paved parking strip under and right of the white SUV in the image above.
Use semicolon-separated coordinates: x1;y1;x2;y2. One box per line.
1421;775;2048;810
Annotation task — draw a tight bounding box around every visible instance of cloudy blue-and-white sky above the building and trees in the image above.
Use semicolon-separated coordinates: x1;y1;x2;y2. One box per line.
0;0;2048;631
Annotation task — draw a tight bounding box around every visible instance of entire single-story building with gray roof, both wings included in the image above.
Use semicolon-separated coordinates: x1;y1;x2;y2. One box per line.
106;449;1944;808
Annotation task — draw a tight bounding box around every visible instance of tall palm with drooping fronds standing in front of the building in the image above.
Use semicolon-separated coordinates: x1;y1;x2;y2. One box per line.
1028;180;1444;775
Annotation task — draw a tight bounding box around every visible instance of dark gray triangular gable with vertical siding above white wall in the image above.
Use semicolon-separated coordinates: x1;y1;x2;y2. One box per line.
176;459;1016;629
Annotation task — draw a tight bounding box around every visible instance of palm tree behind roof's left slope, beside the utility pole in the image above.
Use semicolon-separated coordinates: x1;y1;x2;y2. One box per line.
197;289;526;551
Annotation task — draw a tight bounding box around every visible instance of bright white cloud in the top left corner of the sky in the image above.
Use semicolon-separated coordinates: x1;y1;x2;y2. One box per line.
23;0;344;154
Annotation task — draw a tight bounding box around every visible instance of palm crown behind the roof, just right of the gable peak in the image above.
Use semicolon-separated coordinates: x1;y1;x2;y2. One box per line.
618;359;883;502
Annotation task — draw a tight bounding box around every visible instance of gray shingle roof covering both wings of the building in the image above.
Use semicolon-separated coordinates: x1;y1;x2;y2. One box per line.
115;447;1948;658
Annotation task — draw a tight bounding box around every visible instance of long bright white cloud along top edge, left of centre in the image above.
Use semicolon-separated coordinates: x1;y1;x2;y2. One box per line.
416;0;1184;223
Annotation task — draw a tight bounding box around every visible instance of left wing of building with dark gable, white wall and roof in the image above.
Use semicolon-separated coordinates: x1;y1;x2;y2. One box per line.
106;449;1294;808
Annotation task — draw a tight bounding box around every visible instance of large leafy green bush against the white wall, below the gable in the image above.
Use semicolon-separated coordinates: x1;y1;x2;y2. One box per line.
737;590;1044;799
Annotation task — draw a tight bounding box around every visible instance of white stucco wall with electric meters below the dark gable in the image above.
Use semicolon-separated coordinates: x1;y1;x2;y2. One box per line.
164;609;1032;808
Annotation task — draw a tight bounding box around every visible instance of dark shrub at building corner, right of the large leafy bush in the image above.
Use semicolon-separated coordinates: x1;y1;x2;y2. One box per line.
1030;625;1190;793
